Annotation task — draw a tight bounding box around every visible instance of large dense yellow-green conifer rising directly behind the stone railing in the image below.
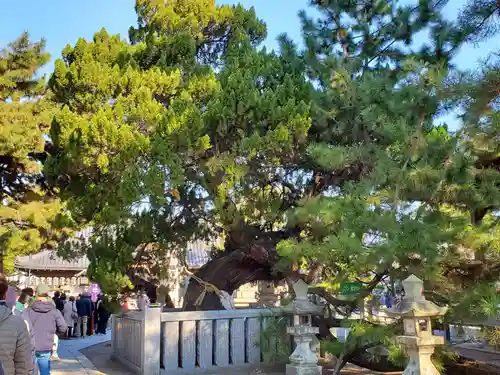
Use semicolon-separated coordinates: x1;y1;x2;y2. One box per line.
46;0;311;300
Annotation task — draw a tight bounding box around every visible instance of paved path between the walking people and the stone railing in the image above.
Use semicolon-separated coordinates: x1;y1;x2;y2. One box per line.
51;332;111;375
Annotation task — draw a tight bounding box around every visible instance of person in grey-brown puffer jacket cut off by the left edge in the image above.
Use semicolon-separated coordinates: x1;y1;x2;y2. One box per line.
0;273;31;375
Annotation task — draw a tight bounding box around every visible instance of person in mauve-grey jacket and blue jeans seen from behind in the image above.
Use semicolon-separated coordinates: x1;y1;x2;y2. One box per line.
22;284;68;375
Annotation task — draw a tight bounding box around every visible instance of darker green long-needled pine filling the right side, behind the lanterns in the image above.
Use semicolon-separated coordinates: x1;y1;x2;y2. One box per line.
281;0;500;302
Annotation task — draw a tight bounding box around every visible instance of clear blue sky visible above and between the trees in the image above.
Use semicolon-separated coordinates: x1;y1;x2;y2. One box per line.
0;0;500;128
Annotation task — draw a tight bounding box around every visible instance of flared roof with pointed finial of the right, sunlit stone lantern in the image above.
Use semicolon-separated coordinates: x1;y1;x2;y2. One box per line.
386;275;448;318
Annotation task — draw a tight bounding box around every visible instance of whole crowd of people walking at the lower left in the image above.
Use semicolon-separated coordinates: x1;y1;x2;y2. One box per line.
0;274;110;375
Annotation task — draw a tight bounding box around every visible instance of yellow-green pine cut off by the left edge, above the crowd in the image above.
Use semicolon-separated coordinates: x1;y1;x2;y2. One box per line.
0;33;71;272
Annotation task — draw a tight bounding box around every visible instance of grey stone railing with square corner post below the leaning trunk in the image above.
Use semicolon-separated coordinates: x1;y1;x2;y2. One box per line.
112;308;279;375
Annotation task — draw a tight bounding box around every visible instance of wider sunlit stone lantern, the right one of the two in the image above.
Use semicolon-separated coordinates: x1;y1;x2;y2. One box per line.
386;275;448;375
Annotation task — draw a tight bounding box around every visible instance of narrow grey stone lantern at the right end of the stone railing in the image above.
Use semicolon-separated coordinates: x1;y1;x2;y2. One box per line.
282;279;322;375
